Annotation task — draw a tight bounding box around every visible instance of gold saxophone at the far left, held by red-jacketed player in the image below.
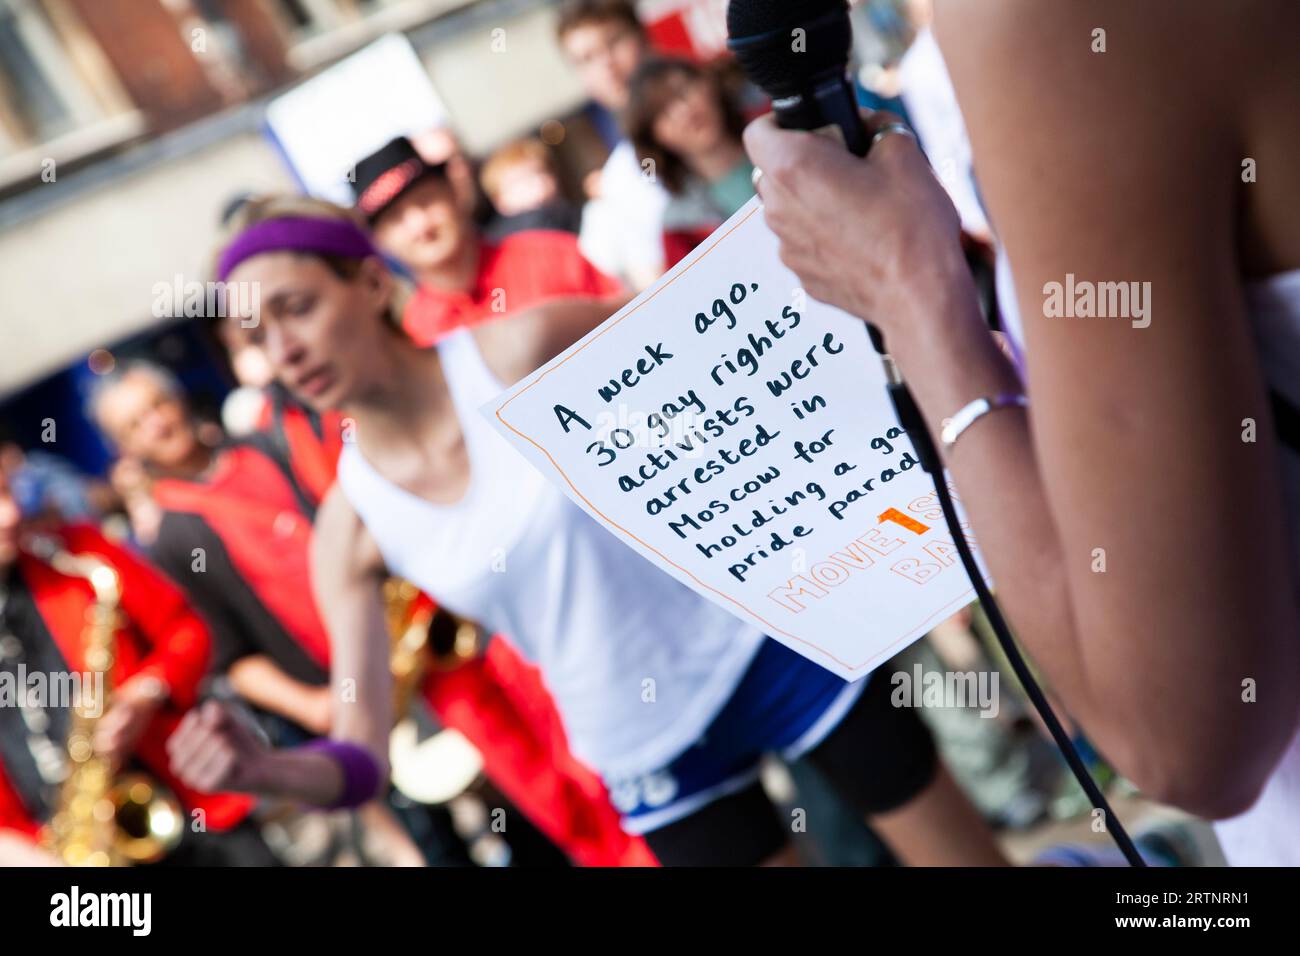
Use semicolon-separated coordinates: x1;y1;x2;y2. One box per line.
29;537;182;866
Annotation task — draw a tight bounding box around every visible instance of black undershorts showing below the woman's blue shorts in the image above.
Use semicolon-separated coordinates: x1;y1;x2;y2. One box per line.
644;667;939;866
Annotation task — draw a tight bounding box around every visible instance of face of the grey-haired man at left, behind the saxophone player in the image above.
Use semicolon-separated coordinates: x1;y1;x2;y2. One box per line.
99;372;209;473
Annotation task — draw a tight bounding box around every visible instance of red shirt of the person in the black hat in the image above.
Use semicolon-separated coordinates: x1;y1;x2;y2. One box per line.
402;229;623;345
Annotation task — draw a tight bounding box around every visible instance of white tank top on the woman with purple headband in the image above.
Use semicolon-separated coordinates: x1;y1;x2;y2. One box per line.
338;329;764;779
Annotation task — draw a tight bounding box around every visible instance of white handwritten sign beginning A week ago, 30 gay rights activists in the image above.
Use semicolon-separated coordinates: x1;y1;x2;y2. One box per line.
482;199;972;680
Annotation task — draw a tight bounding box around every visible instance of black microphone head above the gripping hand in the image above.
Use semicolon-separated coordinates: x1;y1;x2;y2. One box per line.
727;0;853;100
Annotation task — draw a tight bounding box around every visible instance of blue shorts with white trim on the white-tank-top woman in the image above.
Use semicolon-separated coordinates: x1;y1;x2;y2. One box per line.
607;639;871;834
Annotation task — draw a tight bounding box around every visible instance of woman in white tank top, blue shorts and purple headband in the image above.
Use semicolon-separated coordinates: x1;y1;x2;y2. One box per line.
174;190;1005;865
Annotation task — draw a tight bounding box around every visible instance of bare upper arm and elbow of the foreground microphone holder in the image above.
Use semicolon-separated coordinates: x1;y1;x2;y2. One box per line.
940;1;1300;814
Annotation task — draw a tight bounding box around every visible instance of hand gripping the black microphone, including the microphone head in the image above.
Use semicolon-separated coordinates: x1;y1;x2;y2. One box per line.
727;0;969;354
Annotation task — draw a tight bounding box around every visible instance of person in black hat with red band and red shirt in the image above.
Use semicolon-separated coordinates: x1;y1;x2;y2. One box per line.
354;138;621;345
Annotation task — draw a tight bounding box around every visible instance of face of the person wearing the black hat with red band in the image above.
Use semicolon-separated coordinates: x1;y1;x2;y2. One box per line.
372;176;478;289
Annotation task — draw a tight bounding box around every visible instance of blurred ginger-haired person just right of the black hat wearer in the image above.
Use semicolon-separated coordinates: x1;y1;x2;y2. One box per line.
478;139;579;243
